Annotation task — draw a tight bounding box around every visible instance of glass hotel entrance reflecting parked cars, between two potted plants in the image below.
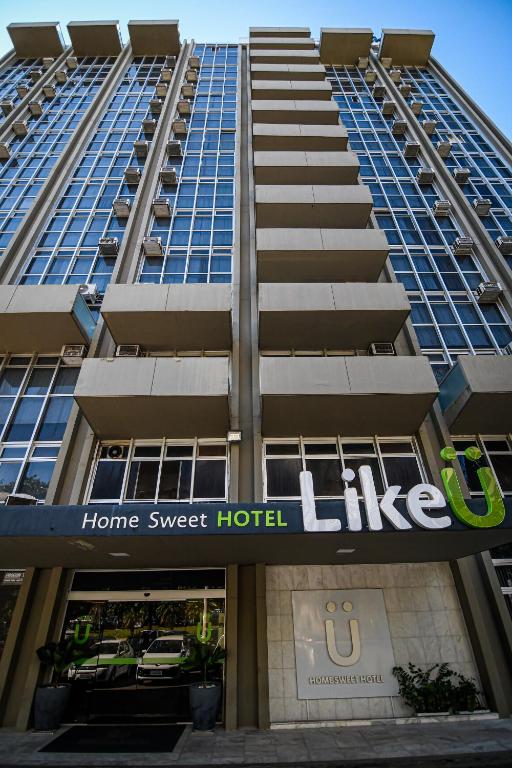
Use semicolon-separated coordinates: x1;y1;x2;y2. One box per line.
62;569;225;723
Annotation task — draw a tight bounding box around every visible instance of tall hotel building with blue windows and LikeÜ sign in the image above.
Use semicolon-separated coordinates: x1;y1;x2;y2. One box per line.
0;21;512;730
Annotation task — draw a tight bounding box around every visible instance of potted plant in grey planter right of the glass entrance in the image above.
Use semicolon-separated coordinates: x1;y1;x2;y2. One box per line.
181;640;226;731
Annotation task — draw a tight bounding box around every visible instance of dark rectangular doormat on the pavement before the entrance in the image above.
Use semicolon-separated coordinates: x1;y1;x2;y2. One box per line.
39;725;185;752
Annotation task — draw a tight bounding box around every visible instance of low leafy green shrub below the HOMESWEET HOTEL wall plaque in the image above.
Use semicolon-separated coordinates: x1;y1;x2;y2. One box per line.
393;663;480;712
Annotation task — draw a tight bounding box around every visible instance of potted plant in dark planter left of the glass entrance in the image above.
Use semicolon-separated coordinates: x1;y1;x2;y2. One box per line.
34;637;90;731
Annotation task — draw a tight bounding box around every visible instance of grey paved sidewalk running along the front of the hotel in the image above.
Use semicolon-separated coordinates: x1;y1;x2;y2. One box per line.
0;719;512;768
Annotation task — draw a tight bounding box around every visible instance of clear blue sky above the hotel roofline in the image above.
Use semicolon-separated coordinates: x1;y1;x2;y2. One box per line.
0;0;512;138
